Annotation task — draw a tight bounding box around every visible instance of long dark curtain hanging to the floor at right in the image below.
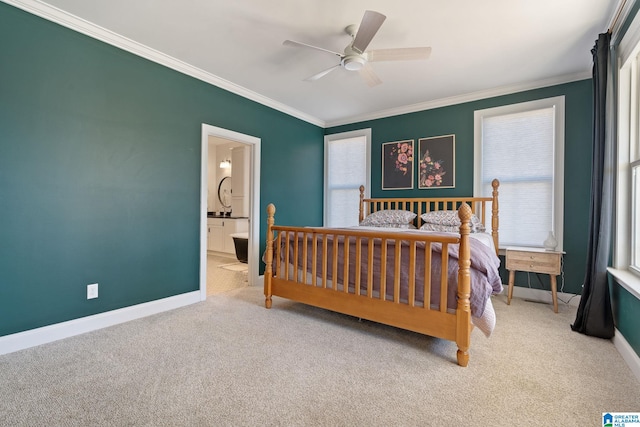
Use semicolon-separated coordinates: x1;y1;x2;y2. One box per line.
571;33;614;338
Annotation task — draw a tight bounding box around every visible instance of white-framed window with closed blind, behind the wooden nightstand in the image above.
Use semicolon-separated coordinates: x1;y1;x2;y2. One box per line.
474;97;564;250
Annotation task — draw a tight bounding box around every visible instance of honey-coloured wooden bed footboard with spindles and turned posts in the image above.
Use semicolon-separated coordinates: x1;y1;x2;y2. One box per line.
264;204;472;366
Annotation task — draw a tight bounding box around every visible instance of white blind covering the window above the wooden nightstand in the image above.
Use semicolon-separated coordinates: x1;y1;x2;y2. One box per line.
482;107;555;247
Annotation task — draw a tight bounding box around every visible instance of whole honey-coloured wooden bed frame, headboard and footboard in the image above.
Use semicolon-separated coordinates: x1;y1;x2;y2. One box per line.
264;180;499;366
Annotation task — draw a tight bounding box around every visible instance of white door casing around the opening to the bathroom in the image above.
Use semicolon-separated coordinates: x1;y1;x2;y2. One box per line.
200;123;260;301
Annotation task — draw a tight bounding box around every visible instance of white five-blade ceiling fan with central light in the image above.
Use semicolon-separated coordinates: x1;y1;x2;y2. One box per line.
282;10;431;86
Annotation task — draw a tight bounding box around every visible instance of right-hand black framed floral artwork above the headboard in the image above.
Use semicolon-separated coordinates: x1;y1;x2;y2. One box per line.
418;135;456;189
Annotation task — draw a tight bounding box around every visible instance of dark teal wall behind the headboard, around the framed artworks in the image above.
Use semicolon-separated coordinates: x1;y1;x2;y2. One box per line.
326;80;592;294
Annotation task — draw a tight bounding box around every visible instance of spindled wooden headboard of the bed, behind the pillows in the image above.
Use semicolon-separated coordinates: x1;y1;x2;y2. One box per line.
358;179;500;251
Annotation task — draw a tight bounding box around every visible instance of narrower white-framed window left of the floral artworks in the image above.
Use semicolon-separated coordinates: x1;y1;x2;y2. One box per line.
324;129;371;227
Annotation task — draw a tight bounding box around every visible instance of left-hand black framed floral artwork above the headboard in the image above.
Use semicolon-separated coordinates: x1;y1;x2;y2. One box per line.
382;139;414;190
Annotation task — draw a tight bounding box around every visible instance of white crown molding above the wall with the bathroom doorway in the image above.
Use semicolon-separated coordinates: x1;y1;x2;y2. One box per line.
1;0;325;128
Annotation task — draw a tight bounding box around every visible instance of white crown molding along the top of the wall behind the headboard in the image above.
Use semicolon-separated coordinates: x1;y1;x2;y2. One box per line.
326;71;591;128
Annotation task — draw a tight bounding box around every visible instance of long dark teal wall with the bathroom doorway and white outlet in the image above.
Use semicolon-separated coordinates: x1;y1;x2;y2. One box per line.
0;3;324;336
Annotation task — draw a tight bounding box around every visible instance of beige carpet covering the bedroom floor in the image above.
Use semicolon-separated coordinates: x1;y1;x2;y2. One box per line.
0;287;640;427
